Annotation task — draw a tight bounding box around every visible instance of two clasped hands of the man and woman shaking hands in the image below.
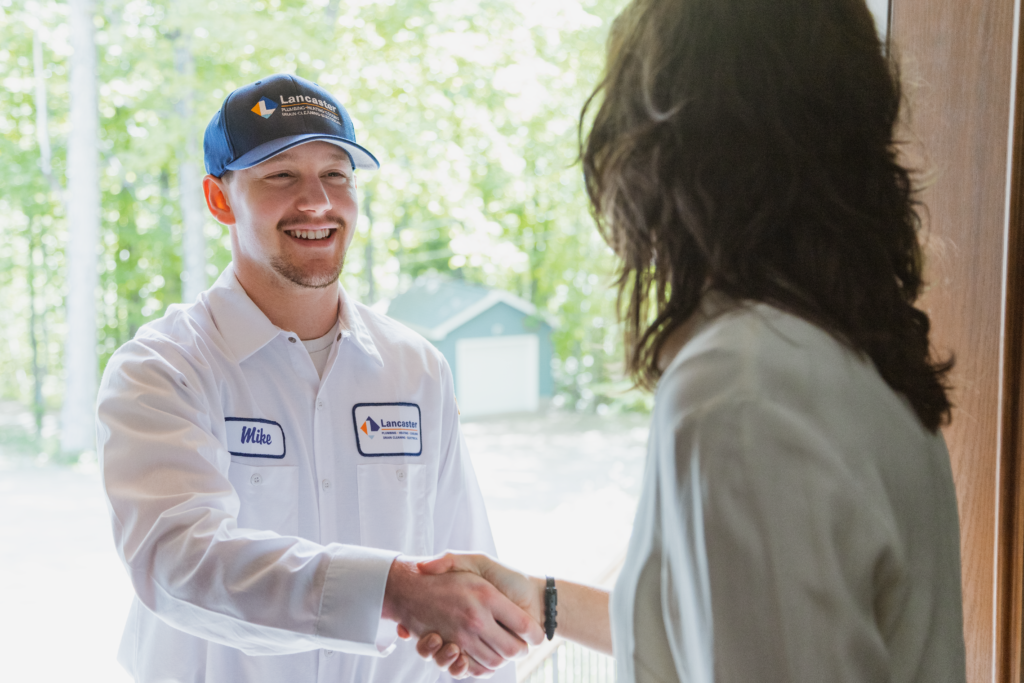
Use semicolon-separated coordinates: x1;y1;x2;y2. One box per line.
382;553;552;678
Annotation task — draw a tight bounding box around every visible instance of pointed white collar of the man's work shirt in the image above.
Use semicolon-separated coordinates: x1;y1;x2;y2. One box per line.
206;263;384;368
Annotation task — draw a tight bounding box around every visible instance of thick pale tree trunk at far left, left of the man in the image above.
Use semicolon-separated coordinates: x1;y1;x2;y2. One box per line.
60;0;99;454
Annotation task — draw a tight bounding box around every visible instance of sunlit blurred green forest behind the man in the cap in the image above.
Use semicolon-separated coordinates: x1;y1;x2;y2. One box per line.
0;0;646;460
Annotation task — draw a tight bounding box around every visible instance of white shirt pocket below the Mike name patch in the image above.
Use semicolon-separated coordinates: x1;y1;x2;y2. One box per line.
227;461;299;536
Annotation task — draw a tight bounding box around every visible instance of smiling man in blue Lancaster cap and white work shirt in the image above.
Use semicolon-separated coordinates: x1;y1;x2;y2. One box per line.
97;75;542;683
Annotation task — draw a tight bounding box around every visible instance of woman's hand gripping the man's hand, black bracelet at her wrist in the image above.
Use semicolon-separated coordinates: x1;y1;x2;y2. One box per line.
398;553;544;678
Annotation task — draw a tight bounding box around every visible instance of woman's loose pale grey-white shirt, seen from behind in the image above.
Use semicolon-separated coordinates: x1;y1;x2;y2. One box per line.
610;296;966;683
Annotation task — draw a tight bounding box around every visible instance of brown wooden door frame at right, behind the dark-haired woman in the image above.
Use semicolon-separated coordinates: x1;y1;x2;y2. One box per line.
888;0;1024;683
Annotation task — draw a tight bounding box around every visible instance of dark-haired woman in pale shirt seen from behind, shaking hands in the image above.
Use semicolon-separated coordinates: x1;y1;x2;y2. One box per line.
405;0;966;682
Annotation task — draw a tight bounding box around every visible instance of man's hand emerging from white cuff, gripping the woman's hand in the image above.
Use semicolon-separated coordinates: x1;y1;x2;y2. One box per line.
382;556;544;676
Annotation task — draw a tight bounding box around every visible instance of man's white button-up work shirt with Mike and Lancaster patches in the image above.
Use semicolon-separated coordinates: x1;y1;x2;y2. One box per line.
97;266;515;683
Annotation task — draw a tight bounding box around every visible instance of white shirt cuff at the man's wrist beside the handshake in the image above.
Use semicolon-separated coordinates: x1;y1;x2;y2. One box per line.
316;545;399;656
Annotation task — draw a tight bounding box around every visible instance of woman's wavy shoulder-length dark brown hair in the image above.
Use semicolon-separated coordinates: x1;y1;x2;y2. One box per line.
581;0;952;431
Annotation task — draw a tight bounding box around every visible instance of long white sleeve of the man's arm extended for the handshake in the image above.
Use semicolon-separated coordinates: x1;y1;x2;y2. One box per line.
96;342;397;655
